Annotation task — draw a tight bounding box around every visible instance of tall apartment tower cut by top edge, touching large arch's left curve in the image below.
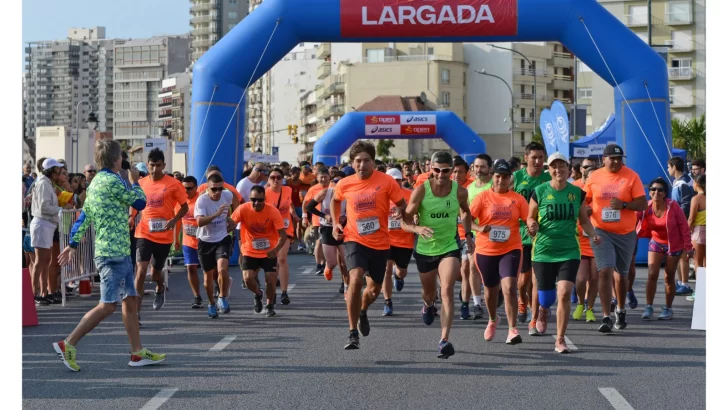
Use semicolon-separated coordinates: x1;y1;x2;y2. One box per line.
190;0;250;64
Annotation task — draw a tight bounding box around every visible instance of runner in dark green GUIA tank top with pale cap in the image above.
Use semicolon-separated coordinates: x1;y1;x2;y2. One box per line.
528;152;601;353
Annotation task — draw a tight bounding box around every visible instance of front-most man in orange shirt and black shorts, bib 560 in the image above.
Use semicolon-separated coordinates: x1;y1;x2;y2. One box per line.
331;141;405;349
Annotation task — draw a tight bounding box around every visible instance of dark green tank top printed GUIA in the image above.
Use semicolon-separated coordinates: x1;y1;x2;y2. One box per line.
531;183;586;262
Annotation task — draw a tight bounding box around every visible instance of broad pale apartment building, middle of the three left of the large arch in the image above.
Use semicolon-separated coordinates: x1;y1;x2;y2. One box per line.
114;35;190;145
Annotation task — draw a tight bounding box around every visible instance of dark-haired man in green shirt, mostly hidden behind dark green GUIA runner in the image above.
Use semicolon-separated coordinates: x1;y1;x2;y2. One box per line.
513;142;551;336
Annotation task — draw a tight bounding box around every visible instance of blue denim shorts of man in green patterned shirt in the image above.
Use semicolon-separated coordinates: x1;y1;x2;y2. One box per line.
94;256;139;303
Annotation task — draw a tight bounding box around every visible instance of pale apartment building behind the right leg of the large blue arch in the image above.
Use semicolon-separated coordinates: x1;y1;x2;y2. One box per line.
577;0;706;127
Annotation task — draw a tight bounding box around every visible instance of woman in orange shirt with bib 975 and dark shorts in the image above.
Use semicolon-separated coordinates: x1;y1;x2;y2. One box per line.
470;159;528;344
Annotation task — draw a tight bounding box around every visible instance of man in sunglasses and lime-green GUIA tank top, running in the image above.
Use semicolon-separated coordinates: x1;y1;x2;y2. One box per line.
404;151;475;359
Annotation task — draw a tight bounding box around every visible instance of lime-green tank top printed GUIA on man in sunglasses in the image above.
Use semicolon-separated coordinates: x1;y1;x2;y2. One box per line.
416;179;460;256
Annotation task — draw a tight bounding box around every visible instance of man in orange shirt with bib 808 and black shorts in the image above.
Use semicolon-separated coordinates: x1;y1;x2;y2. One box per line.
134;148;189;322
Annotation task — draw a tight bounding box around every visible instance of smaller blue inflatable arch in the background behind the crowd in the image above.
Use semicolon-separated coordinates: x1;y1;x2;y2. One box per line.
313;111;485;166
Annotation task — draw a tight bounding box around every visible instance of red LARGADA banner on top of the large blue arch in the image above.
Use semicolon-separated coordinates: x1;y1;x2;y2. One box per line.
340;0;518;38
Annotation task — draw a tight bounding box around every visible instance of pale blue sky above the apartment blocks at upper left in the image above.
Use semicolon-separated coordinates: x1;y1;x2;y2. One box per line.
20;0;190;64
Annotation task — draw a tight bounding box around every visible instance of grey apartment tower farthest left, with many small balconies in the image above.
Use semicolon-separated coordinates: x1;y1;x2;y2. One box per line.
23;27;118;139
